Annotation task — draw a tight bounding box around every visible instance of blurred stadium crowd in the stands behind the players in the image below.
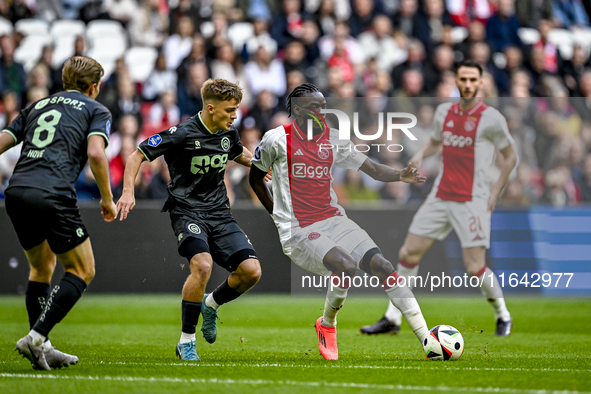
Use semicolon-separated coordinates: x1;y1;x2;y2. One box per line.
0;0;591;206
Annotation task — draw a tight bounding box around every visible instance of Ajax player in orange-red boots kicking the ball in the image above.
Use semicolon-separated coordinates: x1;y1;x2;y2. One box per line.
250;84;429;360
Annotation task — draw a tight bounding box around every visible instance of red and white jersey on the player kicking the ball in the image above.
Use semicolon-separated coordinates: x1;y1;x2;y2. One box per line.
252;122;367;246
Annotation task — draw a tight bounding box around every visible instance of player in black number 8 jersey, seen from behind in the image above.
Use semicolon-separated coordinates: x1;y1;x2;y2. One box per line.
0;56;116;370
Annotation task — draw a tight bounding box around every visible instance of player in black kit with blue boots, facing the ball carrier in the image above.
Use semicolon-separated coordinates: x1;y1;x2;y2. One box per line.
117;79;261;361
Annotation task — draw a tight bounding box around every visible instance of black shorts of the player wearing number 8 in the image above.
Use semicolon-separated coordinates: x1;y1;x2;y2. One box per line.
5;186;88;254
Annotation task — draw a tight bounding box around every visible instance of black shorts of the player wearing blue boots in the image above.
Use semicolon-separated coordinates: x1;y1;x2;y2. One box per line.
170;208;257;272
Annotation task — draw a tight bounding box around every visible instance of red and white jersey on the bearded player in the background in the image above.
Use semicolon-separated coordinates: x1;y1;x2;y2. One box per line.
431;101;513;202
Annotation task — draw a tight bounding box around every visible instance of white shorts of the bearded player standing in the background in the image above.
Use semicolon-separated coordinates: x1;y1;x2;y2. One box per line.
408;195;491;249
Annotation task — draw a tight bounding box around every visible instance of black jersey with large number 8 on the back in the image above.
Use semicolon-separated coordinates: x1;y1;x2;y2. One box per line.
3;90;111;198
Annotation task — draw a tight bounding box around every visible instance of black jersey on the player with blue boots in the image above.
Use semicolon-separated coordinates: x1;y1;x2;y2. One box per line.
138;115;243;210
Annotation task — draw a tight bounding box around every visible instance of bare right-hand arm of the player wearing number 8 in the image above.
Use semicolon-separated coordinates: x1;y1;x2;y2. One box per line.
87;134;117;222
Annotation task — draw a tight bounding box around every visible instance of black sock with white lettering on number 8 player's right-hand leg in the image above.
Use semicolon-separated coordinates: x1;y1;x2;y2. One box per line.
33;272;86;336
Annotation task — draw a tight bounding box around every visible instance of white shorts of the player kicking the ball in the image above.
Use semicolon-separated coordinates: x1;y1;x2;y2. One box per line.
284;216;377;276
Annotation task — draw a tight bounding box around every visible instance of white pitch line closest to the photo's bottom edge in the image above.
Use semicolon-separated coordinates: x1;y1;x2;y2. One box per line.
0;373;591;394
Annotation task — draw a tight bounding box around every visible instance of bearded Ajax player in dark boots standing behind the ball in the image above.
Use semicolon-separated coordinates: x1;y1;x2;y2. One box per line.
361;60;517;336
